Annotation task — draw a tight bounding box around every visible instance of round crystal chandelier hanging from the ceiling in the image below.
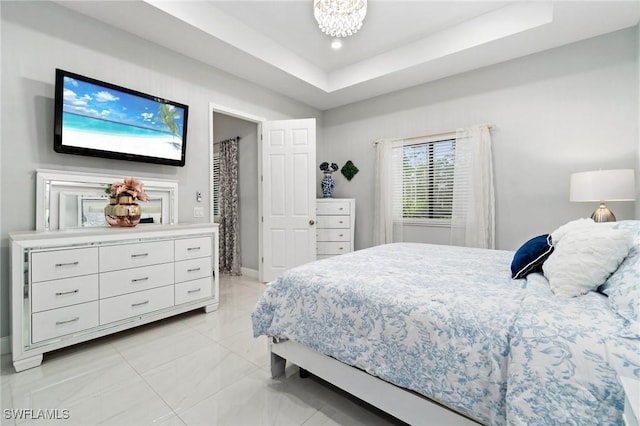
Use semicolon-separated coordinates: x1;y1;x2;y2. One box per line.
313;0;367;37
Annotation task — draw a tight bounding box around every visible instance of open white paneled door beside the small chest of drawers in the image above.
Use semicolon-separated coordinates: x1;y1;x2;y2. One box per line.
258;118;316;282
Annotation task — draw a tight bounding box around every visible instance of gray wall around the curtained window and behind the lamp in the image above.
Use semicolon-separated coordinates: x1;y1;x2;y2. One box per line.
317;28;640;253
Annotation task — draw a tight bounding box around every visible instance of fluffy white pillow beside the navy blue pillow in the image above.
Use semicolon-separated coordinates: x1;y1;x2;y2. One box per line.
542;219;633;297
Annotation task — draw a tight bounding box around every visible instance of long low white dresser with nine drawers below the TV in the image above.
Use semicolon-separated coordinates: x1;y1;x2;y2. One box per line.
10;224;219;371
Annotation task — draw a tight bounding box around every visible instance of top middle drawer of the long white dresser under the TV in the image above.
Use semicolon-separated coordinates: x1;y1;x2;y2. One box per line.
100;241;173;272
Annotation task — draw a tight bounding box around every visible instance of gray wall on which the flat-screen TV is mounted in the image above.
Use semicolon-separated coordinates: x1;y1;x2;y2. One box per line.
0;1;321;336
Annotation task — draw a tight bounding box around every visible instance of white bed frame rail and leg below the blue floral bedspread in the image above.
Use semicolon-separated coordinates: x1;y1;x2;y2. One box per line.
269;337;479;425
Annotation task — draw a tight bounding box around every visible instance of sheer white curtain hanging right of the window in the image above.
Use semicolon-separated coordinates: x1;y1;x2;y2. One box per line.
451;125;495;248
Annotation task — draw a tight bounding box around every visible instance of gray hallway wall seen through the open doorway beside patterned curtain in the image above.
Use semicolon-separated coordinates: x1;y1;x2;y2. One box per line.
213;113;259;272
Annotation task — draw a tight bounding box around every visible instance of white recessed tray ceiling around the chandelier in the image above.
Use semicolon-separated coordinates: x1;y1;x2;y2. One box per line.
58;0;640;110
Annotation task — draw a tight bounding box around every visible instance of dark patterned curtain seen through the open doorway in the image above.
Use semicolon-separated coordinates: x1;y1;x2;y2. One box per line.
219;138;241;275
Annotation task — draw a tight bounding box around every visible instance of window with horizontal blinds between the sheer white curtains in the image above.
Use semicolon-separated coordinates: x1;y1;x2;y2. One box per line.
394;139;455;222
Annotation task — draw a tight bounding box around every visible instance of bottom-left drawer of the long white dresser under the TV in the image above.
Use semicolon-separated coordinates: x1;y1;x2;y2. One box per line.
31;301;98;343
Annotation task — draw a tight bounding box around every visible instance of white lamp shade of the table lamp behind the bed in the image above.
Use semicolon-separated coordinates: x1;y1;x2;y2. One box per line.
569;169;636;201
